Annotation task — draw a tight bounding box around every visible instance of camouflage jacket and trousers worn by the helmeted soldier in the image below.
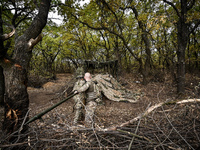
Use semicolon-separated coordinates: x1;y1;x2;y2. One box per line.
73;79;85;124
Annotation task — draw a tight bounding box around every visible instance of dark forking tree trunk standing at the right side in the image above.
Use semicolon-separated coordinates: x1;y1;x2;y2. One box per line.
163;0;200;94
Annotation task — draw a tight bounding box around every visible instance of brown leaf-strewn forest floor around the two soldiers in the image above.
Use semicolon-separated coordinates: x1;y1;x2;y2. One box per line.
28;74;200;149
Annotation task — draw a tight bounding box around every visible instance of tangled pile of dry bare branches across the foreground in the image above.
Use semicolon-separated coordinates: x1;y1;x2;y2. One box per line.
0;99;200;150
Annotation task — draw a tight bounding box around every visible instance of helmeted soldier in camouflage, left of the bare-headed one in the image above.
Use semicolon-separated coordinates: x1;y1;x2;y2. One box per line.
73;68;85;125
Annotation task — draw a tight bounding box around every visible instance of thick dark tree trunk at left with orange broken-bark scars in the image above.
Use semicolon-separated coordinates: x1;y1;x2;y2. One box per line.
3;0;50;149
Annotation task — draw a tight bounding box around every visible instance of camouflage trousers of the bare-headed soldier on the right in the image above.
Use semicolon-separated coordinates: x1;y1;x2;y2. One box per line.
85;101;97;127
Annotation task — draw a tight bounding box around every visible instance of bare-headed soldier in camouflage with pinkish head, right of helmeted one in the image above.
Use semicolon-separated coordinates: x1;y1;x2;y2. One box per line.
77;73;98;127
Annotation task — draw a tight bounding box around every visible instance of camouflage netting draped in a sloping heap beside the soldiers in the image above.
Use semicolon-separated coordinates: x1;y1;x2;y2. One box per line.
93;74;137;103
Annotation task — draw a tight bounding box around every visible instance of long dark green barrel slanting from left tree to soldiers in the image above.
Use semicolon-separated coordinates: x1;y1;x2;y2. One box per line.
25;93;78;125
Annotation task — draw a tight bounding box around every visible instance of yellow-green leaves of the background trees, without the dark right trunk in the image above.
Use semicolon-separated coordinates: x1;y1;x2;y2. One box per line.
27;0;199;79
